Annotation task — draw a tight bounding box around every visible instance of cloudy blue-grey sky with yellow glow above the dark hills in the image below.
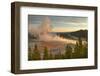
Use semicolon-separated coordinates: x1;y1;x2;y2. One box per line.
28;15;88;32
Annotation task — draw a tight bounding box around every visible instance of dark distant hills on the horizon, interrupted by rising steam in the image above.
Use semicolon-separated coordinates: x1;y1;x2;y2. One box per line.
28;30;88;41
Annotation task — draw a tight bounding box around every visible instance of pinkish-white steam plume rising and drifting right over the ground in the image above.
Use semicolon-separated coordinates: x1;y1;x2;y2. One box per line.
29;17;76;44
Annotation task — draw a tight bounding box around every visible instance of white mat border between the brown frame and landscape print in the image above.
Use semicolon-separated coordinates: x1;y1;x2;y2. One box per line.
20;7;94;70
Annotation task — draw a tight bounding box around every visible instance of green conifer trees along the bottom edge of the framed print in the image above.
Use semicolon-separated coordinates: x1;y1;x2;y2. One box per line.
28;38;88;60
